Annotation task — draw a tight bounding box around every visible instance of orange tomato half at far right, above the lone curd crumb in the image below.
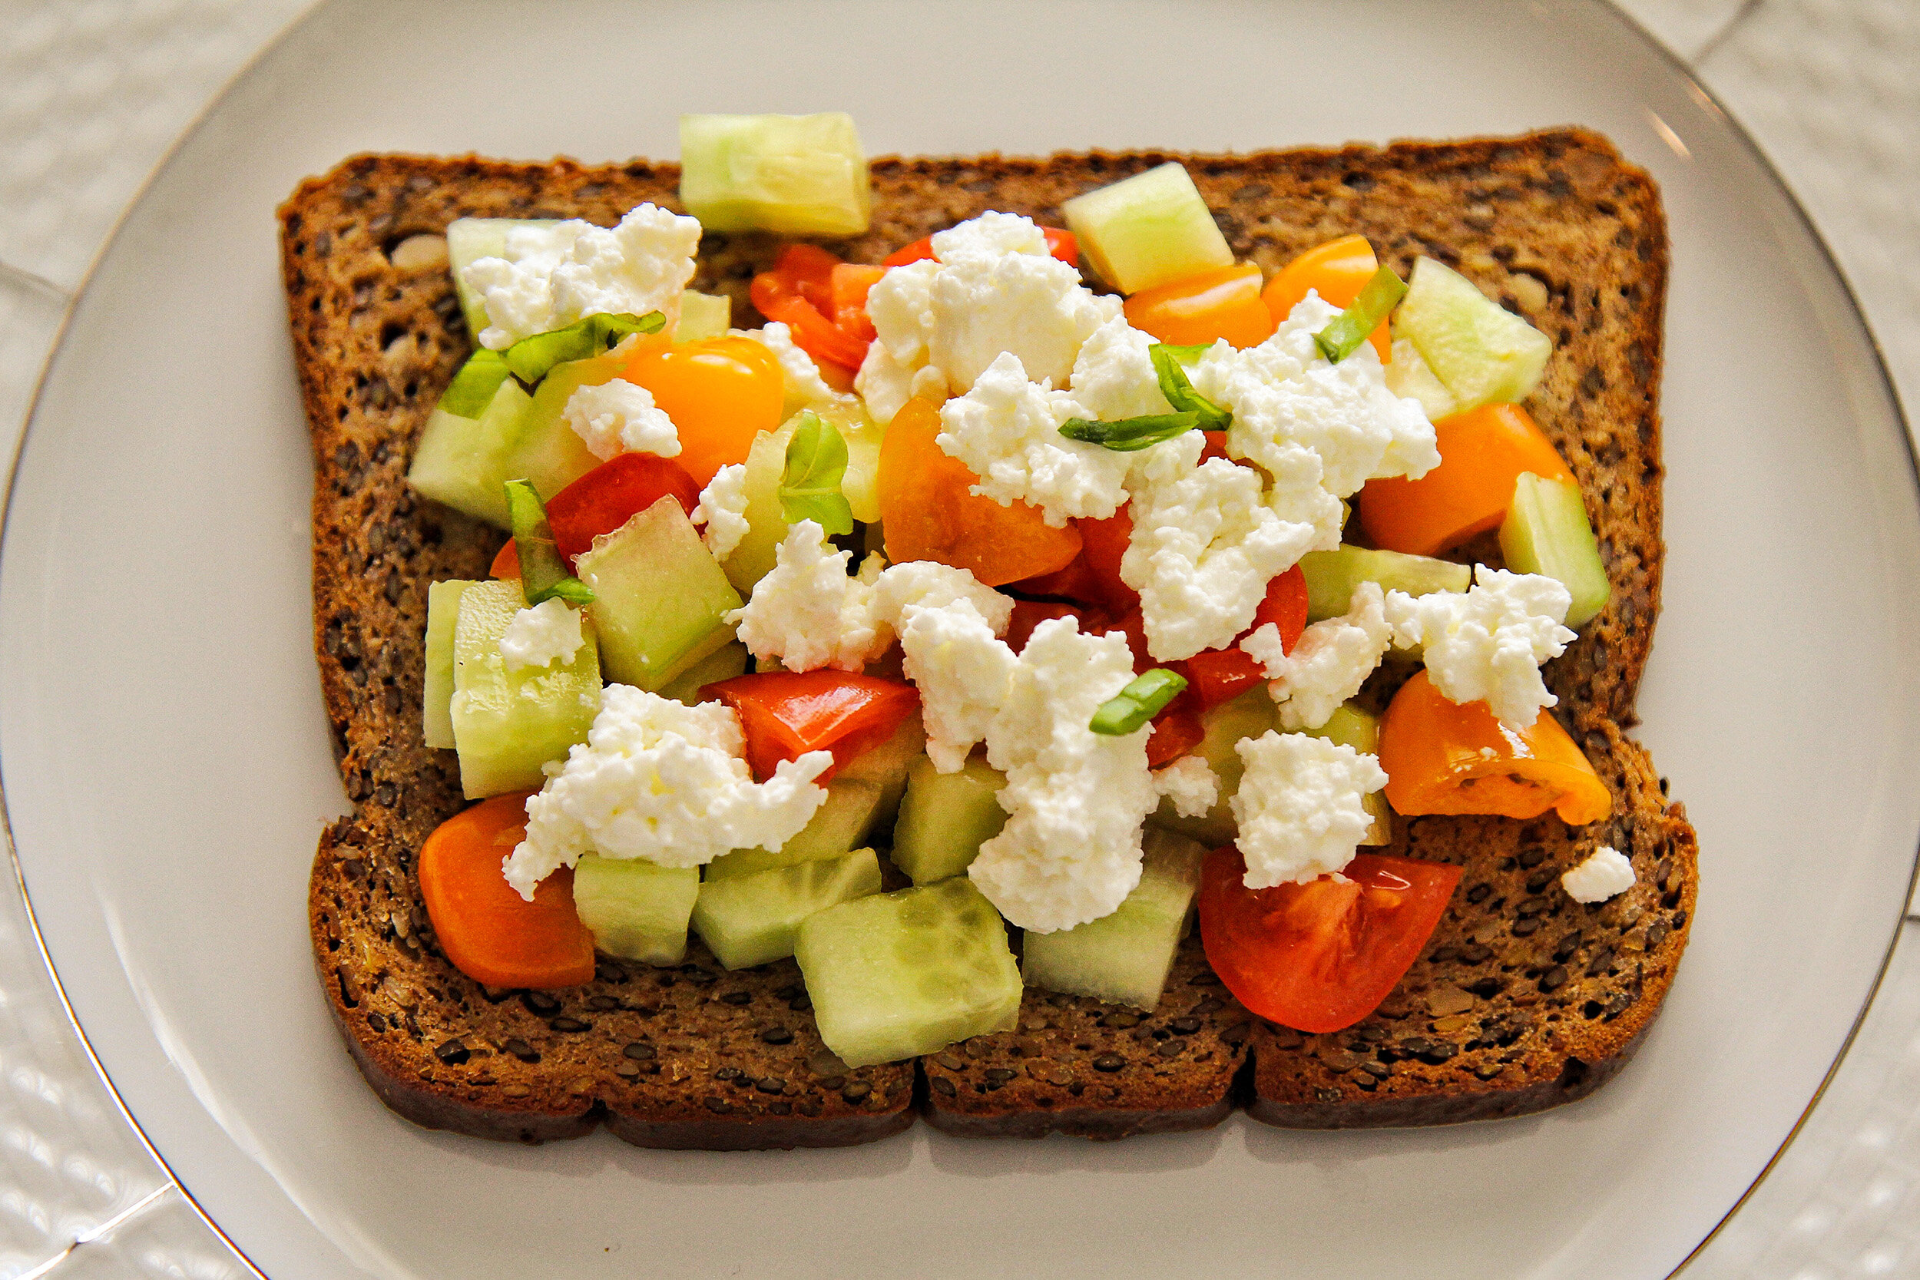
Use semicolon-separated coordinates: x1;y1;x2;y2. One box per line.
1380;670;1613;827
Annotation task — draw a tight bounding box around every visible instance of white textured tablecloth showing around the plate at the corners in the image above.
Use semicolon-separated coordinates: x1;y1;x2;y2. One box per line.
0;0;1920;1280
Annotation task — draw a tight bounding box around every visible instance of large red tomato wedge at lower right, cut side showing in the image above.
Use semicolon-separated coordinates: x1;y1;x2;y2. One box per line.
1200;844;1461;1032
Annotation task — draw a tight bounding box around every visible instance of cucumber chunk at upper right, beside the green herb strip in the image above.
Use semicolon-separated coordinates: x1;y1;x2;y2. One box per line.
1394;257;1553;413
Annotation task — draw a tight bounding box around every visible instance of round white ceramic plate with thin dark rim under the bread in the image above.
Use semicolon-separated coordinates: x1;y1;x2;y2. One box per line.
0;0;1920;1280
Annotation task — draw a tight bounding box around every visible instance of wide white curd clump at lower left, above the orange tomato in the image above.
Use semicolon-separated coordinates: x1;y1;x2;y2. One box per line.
503;685;833;900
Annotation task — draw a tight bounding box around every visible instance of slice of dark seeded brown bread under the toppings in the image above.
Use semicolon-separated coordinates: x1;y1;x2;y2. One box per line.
280;130;1695;1148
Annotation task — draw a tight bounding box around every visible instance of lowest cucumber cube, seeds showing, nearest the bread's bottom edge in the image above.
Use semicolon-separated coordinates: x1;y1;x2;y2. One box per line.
793;875;1021;1067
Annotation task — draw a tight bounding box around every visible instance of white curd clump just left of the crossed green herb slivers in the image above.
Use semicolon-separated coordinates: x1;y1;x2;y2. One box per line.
935;351;1140;528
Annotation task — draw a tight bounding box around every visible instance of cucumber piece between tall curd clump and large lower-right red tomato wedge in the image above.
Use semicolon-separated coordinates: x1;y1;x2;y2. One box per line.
1020;829;1206;1009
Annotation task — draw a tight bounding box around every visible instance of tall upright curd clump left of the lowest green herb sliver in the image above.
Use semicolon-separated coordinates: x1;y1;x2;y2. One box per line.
975;618;1160;933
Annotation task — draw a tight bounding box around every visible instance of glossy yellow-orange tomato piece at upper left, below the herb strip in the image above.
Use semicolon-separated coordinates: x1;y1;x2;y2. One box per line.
620;338;787;489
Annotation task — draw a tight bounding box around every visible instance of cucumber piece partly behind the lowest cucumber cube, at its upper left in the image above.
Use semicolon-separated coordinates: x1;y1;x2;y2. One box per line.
693;848;879;969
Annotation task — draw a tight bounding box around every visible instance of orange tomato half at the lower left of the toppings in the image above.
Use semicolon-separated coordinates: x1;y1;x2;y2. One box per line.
419;791;593;988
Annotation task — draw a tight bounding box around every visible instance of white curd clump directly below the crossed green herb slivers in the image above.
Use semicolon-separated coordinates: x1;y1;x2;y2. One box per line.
1119;432;1321;662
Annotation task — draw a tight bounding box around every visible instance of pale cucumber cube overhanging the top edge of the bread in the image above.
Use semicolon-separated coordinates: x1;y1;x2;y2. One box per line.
680;111;874;236
